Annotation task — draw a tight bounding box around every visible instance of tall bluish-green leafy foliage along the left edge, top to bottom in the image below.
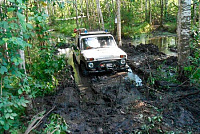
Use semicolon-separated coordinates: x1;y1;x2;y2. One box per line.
0;0;31;133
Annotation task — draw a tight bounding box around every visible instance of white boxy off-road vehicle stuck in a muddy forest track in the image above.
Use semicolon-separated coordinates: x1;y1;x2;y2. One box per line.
73;29;128;75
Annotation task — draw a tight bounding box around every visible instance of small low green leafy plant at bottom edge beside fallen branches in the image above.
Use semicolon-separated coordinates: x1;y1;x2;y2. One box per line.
44;114;70;134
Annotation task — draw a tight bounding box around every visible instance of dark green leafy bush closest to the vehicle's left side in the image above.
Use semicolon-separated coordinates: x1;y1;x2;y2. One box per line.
29;49;66;95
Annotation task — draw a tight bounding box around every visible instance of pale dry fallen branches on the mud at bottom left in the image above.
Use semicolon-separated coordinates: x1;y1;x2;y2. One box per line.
24;106;55;134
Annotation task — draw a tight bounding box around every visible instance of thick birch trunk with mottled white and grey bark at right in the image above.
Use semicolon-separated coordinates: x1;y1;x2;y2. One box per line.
177;0;191;82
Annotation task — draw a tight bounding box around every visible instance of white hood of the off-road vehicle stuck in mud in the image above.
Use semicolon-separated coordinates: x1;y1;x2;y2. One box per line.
81;47;127;61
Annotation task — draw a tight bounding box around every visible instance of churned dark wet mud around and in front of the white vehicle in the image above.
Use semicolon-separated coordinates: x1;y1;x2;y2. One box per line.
34;44;200;134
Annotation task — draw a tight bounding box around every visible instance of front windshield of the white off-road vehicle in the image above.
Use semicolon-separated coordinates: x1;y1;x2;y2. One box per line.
81;36;115;50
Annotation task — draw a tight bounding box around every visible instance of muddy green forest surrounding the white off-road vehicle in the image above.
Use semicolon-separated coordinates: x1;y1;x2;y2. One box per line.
0;0;200;134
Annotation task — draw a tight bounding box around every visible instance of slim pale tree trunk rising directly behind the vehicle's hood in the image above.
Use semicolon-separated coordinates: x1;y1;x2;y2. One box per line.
117;0;122;46
